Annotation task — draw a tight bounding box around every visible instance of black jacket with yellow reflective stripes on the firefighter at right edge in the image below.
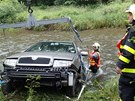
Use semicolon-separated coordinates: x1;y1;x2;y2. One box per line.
116;26;135;79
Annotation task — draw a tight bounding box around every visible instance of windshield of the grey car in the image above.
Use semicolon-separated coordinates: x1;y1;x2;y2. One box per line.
25;42;76;53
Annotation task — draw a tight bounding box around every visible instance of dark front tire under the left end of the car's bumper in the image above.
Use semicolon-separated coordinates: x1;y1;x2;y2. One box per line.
1;81;14;95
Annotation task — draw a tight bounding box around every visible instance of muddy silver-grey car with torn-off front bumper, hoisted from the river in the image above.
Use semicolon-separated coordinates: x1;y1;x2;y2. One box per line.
1;41;81;96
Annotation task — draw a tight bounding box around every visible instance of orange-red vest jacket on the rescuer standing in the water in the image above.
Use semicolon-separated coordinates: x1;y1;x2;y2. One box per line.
89;51;100;68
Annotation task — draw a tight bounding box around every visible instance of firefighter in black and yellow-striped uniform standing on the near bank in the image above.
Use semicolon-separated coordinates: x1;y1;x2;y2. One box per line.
116;4;135;101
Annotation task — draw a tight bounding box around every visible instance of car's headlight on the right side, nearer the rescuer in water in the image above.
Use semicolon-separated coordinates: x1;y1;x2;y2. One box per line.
53;60;72;67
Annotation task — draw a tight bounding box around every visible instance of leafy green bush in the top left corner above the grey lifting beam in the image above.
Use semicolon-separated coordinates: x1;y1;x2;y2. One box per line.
0;0;23;23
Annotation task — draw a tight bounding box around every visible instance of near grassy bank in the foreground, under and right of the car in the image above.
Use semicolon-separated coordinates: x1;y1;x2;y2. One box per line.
0;78;119;101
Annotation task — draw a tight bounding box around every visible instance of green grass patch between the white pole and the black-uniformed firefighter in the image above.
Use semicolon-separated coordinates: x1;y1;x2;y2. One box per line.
81;78;119;101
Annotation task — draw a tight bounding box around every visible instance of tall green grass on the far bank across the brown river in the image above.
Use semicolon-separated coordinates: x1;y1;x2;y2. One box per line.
1;0;131;30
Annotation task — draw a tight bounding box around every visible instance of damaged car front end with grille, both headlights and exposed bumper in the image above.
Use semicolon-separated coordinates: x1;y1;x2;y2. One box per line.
3;54;79;86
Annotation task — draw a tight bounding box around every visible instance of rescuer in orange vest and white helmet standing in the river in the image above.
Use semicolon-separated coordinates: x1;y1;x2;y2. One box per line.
88;42;100;73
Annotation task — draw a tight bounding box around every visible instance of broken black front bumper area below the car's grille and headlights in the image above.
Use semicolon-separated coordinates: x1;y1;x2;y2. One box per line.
3;69;73;86
